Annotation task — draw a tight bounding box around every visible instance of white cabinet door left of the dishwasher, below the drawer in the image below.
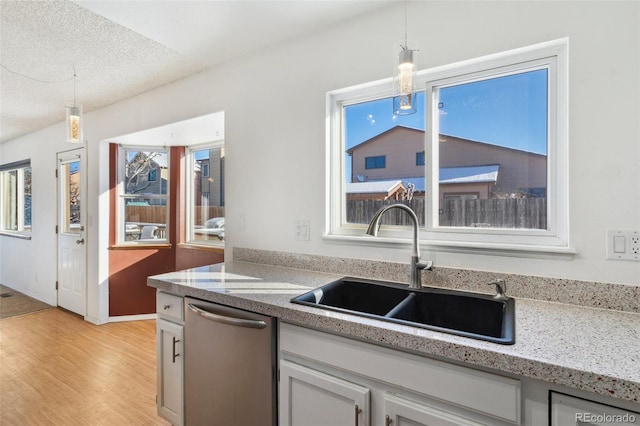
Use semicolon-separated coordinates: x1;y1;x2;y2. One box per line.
156;319;184;426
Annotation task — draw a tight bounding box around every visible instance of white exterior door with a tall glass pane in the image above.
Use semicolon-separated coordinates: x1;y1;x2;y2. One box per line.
58;148;87;316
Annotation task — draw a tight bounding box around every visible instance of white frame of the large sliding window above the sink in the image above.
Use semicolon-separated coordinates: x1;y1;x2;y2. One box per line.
324;38;576;258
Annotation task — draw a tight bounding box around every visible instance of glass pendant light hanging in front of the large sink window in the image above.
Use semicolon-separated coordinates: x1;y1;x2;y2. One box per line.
393;2;418;115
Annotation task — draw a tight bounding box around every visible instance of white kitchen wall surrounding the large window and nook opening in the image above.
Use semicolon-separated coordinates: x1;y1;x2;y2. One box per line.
0;1;640;318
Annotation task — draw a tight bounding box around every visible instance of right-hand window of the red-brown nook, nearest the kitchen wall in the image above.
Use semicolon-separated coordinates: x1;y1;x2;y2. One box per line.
187;143;225;247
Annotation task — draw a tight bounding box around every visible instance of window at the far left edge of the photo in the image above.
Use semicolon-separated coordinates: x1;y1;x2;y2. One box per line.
0;160;31;236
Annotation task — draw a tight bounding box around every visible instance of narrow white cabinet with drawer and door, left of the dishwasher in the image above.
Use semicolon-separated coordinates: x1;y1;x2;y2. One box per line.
156;292;184;426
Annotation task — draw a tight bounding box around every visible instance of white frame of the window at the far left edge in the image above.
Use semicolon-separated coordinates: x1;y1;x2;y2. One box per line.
0;159;33;239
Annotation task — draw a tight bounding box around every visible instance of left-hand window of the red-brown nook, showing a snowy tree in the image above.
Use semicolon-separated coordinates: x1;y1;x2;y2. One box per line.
118;147;169;244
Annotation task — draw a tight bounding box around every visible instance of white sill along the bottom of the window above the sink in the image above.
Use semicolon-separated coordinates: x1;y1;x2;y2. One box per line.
322;235;578;260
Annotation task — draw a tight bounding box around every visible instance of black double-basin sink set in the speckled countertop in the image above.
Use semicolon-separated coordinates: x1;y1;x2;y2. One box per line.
291;277;515;345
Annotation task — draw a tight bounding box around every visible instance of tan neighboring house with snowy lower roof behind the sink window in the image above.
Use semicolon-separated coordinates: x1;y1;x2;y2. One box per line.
347;126;547;199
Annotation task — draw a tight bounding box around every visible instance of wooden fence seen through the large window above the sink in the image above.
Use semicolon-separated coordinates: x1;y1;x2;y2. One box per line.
347;198;547;229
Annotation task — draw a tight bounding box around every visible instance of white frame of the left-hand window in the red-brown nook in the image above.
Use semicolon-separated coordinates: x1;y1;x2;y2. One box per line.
116;145;171;246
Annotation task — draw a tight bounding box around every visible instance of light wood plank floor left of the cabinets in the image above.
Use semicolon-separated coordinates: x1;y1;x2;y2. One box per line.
0;309;169;426
